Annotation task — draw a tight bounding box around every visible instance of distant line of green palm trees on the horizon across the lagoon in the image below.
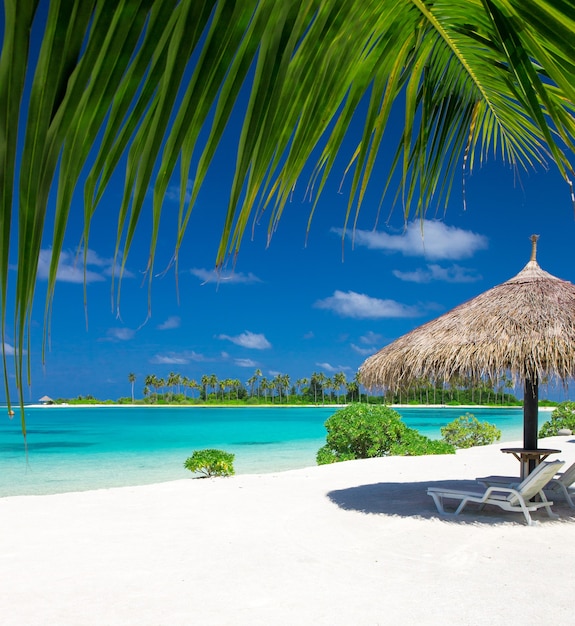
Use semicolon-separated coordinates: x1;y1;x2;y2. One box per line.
115;369;520;404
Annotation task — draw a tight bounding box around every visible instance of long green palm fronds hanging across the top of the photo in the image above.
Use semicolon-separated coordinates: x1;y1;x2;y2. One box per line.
0;0;575;428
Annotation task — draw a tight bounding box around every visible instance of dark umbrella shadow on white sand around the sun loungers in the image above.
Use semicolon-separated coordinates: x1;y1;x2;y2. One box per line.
327;480;575;524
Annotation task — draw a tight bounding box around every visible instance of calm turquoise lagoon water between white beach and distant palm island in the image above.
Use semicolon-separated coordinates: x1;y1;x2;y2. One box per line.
0;406;547;497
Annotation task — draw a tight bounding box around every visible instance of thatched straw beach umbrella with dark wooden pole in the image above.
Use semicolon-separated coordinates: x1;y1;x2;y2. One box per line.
359;235;575;450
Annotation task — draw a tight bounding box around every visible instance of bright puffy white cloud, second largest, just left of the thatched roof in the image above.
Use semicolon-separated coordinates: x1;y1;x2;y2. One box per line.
314;290;421;319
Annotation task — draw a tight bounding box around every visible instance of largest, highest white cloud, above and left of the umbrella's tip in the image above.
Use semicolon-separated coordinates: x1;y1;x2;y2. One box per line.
333;220;488;260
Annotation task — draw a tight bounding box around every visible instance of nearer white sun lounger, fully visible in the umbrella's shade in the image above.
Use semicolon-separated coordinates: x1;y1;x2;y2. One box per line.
427;461;564;526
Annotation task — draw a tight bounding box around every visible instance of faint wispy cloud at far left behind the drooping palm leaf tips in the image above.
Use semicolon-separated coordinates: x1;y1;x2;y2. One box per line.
38;249;133;284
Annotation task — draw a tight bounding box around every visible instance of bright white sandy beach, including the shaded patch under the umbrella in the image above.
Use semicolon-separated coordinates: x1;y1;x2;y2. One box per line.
0;437;575;626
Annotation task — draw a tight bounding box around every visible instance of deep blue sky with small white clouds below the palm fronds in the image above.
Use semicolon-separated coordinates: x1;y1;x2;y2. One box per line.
0;9;575;401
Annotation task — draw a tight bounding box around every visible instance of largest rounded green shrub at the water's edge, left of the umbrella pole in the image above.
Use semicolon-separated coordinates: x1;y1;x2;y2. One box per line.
316;404;454;465
